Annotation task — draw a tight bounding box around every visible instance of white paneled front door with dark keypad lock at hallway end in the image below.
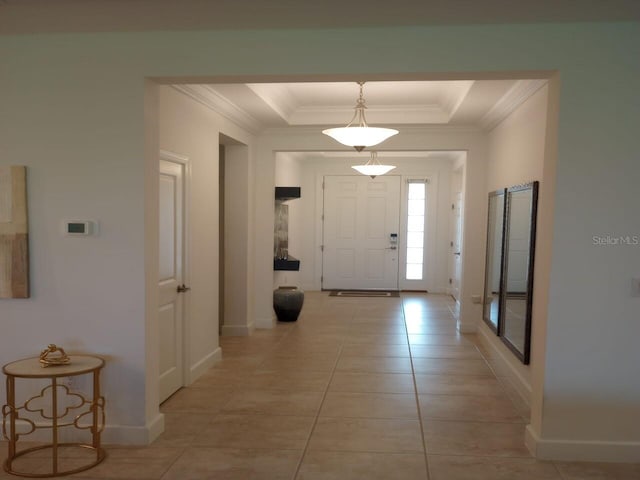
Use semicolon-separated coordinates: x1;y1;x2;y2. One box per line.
322;175;400;289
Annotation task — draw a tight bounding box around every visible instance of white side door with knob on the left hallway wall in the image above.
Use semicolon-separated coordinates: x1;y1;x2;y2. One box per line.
158;160;184;402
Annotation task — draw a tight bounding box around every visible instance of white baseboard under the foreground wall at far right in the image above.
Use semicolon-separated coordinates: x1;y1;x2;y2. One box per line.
525;425;640;463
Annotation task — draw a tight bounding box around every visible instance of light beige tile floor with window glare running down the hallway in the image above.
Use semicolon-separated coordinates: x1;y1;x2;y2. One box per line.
0;292;640;480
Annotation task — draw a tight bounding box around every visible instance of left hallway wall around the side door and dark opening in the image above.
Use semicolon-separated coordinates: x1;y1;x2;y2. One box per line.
159;87;253;344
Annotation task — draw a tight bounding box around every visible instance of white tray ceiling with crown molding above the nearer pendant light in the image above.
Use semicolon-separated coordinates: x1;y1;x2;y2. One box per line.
175;80;546;133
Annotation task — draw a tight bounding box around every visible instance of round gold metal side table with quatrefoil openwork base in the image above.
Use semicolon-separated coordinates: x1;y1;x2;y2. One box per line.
2;355;106;478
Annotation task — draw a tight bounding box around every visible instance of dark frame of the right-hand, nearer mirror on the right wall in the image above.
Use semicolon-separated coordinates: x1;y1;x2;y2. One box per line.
498;181;539;365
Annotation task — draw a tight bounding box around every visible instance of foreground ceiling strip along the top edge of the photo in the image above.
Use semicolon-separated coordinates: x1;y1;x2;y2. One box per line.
0;0;640;34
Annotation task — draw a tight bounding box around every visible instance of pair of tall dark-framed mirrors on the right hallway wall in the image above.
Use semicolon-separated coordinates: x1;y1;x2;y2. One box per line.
484;182;538;364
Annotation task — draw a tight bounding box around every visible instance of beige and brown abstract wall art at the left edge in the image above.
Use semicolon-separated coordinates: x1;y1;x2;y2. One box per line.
0;166;29;298
